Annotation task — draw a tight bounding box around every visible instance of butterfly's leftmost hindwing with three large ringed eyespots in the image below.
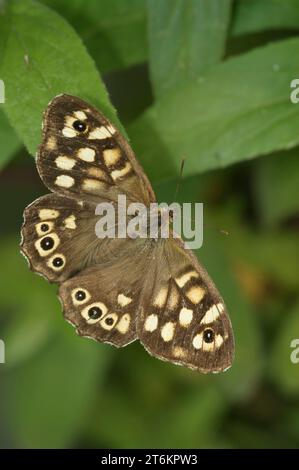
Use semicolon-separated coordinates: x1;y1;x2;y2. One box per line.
21;194;137;282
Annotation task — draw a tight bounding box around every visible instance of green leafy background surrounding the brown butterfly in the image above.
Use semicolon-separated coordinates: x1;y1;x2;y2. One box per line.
0;0;299;448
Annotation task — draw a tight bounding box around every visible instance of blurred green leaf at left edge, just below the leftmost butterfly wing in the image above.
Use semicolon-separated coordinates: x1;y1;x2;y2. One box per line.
0;238;61;369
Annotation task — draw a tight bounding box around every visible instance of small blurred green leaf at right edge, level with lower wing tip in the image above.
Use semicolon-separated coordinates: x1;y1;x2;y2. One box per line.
268;302;299;397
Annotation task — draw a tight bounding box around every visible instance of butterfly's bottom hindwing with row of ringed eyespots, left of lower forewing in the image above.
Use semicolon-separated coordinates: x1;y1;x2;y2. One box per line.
59;240;151;347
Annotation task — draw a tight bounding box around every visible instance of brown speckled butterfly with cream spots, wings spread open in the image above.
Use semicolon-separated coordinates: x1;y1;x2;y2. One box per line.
21;94;234;373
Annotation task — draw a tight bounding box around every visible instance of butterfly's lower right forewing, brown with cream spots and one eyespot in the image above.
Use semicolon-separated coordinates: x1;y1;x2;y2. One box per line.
137;239;234;373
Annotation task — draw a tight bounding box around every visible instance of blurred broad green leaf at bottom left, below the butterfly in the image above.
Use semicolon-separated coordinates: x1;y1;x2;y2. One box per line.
1;329;110;448
